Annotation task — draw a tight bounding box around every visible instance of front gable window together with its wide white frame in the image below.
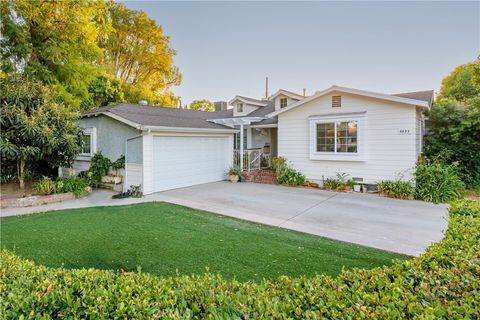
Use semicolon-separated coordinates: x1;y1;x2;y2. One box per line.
310;114;363;161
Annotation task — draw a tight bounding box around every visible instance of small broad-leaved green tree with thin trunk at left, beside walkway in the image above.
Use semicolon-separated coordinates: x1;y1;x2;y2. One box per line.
0;76;82;189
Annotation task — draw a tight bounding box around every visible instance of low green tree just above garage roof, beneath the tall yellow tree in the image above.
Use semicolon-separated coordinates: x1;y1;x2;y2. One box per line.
82;75;124;110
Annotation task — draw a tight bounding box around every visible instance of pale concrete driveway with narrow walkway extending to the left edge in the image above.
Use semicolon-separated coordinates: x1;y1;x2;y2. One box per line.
0;182;447;255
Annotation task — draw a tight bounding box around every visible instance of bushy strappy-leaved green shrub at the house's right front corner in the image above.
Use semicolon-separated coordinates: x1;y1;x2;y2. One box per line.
415;160;465;203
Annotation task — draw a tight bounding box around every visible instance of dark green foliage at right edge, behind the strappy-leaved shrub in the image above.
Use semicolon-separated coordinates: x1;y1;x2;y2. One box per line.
425;101;480;188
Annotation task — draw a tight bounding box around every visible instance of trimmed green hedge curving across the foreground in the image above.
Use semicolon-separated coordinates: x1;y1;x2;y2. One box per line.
0;201;480;319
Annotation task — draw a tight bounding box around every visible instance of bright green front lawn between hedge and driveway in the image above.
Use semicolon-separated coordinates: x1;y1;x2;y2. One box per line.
0;202;408;280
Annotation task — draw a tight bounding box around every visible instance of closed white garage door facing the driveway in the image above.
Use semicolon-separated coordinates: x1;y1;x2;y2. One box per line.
152;136;231;192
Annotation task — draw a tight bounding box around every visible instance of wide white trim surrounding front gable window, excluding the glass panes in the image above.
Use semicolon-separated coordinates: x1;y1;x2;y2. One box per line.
309;113;365;161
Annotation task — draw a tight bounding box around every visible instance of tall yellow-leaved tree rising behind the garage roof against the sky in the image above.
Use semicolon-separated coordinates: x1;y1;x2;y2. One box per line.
100;2;181;104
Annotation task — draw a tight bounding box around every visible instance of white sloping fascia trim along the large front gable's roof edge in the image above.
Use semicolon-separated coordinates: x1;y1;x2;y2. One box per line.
267;85;430;117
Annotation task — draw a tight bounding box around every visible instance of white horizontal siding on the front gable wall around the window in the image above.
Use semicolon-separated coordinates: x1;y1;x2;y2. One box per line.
278;94;417;183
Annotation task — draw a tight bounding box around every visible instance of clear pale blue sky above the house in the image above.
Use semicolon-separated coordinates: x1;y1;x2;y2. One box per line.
125;1;480;104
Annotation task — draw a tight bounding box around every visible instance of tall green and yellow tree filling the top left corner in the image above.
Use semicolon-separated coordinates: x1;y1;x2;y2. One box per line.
0;0;108;105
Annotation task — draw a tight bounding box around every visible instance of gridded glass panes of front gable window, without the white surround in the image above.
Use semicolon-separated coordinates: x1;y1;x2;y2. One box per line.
317;121;358;153
